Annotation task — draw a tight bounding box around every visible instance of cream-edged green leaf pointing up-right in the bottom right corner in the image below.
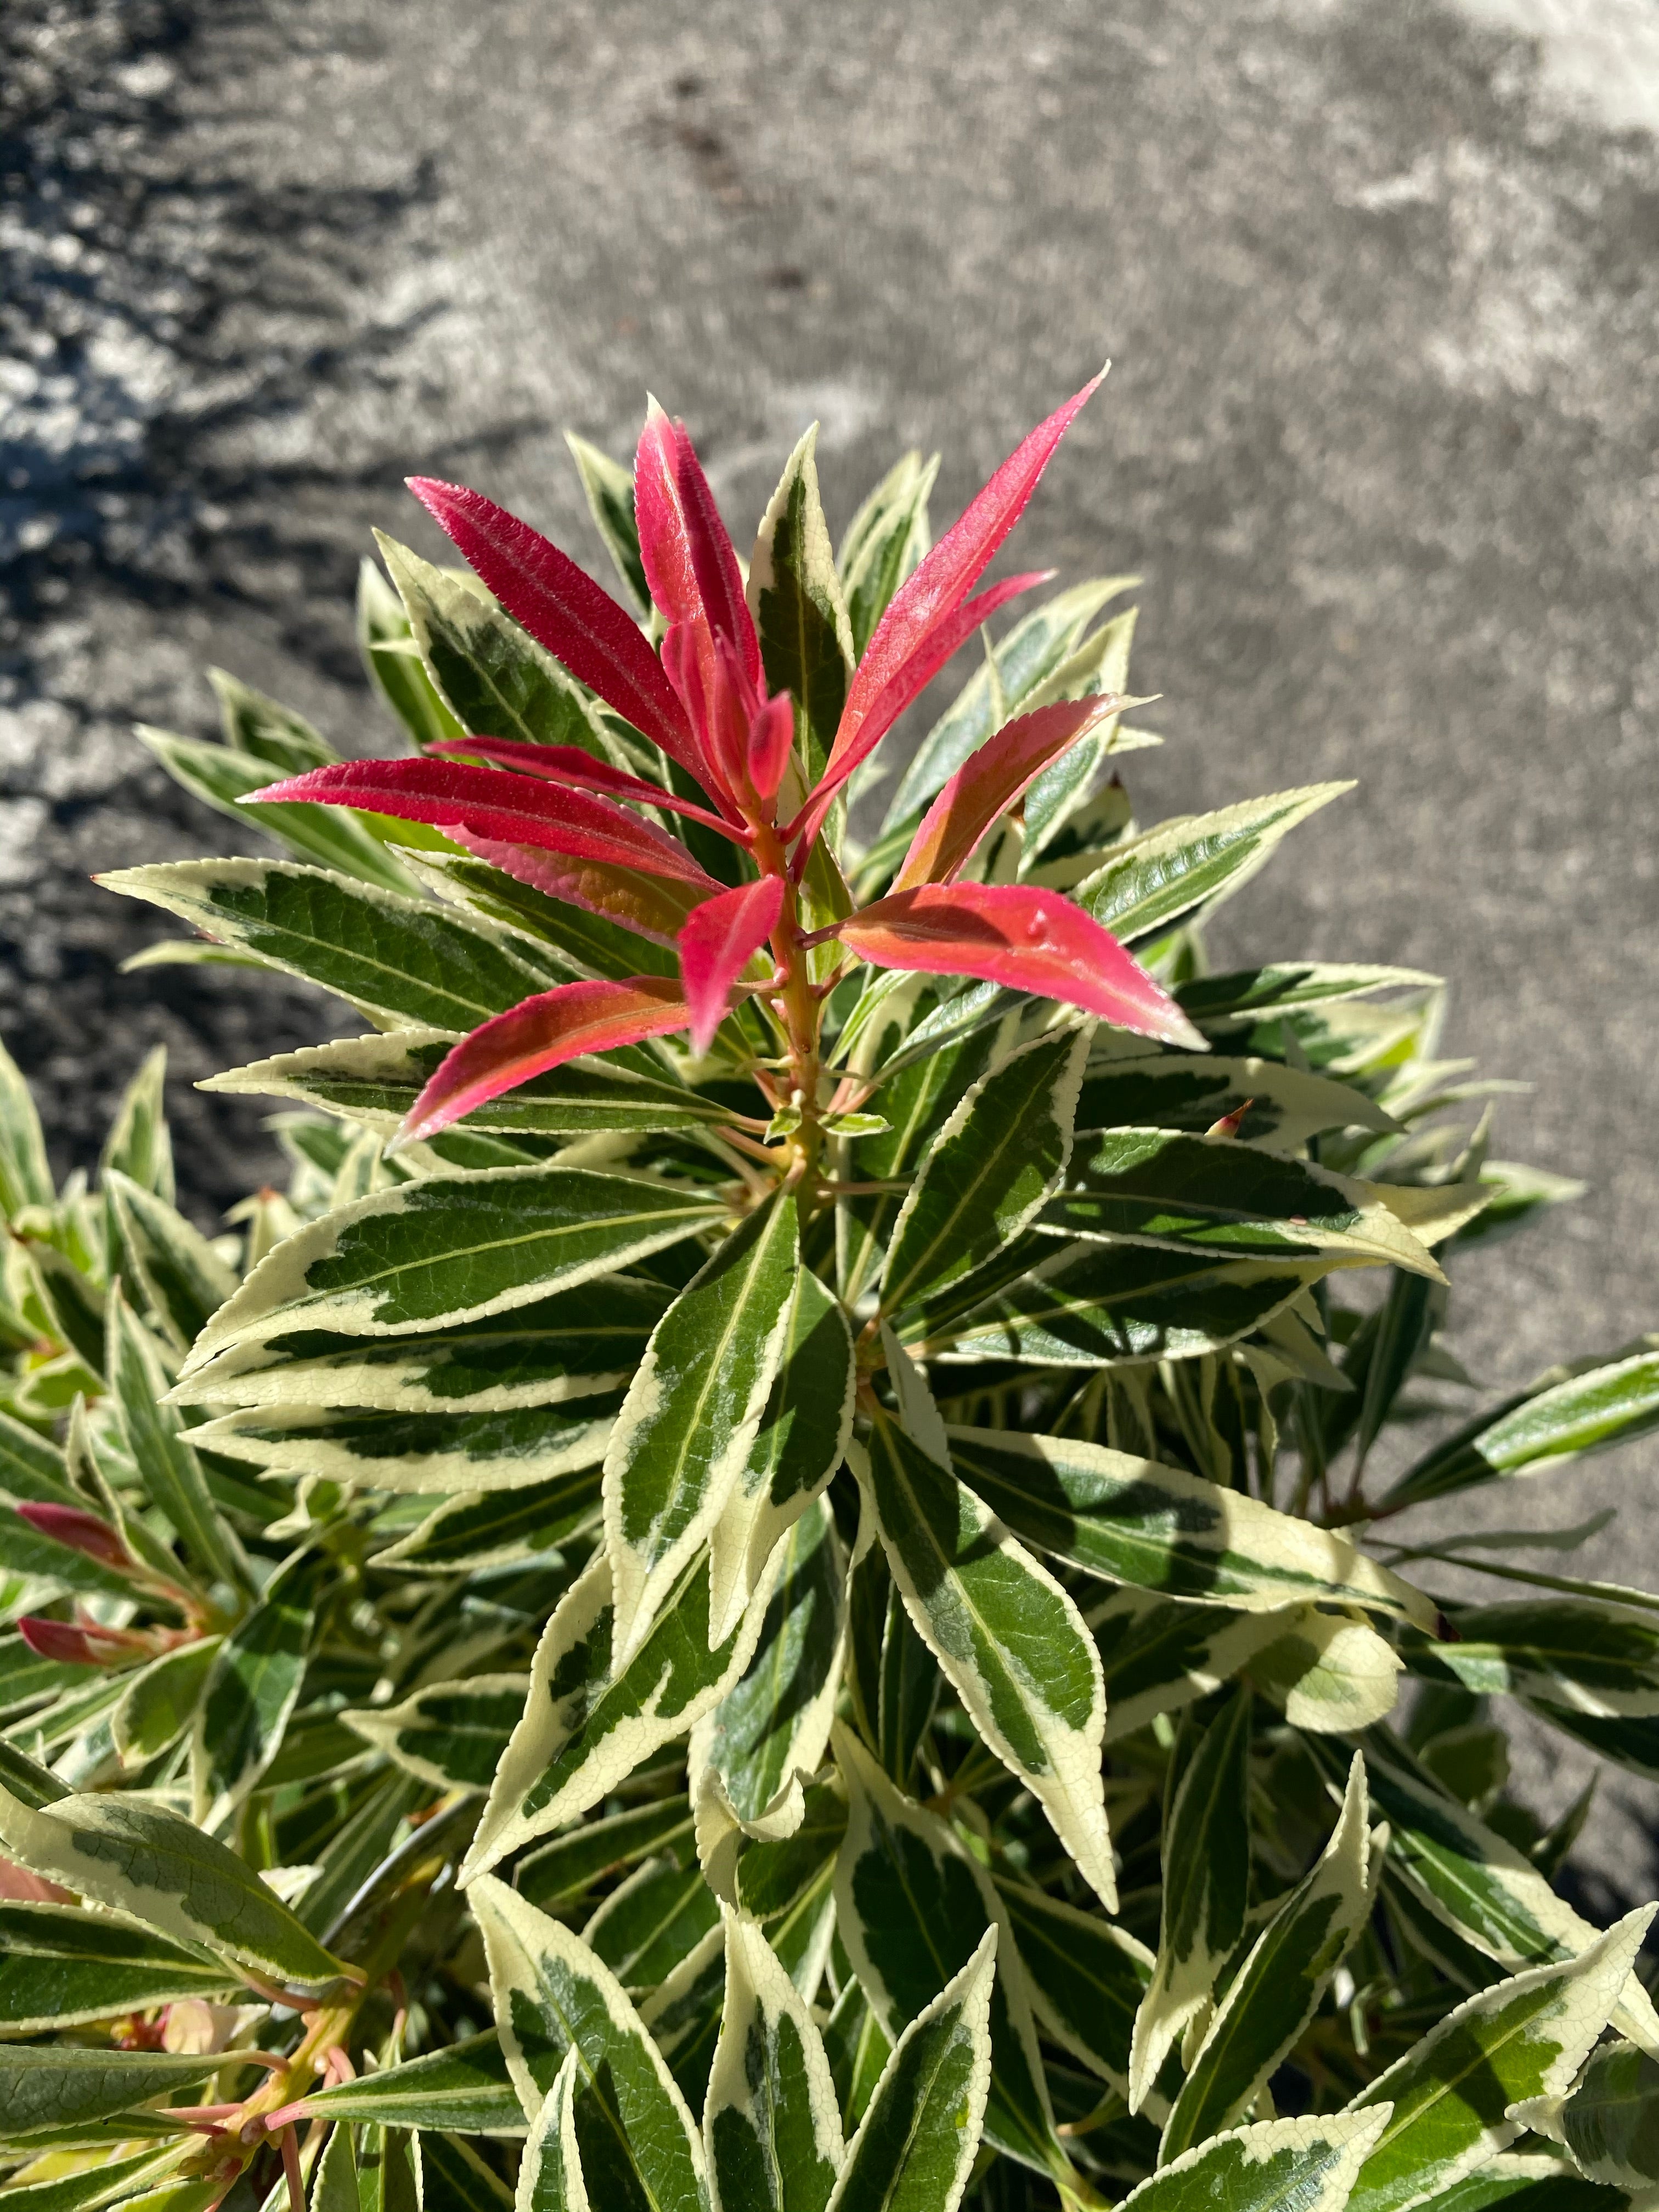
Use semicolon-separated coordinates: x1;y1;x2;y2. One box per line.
1350;1907;1652;2212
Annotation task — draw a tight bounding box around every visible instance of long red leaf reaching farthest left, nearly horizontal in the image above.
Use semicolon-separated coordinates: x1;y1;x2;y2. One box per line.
248;754;710;885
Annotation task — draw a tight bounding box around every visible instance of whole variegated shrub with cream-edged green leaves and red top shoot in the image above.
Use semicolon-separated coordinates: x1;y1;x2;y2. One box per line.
0;387;1659;2212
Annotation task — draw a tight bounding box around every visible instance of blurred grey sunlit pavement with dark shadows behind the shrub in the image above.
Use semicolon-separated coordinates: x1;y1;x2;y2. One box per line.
0;0;1659;1871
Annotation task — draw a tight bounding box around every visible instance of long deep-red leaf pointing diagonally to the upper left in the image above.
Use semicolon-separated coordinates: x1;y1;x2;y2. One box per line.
409;476;703;778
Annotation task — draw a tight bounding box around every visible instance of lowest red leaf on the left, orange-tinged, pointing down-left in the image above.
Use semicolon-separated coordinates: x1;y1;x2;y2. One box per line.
398;975;686;1144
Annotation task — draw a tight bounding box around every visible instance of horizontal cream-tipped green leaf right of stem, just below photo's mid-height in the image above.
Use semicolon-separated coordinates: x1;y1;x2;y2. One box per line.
1053;1128;1444;1283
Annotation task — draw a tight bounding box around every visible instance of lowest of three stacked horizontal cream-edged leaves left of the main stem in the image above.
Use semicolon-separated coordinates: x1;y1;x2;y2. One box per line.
190;1391;622;1491
